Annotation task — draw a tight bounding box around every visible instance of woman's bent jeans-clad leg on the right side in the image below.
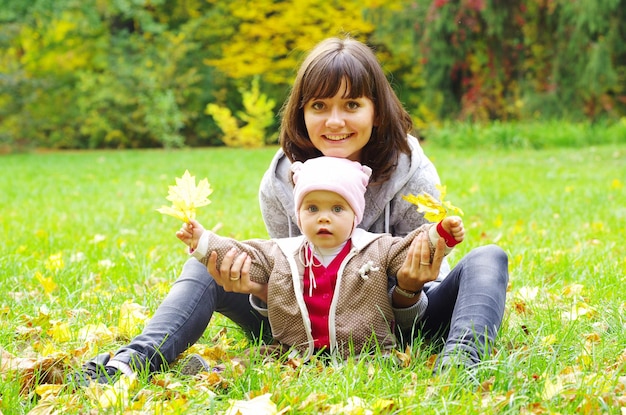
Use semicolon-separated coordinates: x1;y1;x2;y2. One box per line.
419;245;509;368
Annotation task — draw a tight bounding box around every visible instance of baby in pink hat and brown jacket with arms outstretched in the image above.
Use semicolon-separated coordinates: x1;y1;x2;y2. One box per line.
176;157;465;360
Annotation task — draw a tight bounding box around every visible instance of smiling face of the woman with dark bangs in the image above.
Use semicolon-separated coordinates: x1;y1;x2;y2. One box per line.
304;83;374;162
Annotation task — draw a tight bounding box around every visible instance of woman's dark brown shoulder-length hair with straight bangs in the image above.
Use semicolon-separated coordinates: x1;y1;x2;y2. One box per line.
280;37;413;183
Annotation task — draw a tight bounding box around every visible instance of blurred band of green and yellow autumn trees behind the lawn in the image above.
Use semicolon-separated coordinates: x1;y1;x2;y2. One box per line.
0;0;626;152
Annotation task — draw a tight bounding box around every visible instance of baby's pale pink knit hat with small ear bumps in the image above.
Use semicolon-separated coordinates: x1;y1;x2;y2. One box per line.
291;156;372;227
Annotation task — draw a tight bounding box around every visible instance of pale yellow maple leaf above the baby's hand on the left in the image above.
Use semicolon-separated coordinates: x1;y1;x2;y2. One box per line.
157;170;213;222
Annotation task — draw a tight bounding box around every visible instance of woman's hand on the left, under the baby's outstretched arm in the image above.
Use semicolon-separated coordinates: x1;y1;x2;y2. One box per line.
207;248;267;303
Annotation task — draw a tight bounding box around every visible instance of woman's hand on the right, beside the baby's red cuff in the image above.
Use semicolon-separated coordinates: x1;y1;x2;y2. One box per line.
396;232;446;292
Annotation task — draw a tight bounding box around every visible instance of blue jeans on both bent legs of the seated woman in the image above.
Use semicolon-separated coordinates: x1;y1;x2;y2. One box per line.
113;245;508;372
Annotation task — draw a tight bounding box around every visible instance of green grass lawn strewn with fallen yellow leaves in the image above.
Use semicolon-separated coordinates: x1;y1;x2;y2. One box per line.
0;144;626;414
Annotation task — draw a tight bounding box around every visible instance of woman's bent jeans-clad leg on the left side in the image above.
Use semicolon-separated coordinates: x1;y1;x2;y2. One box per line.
111;258;269;372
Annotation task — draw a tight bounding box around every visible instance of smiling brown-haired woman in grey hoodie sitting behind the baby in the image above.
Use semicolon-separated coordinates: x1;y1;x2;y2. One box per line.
73;38;508;383
